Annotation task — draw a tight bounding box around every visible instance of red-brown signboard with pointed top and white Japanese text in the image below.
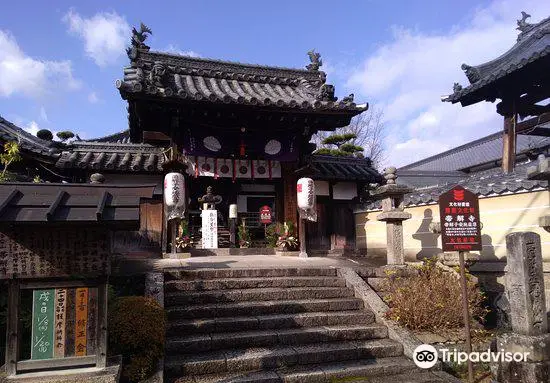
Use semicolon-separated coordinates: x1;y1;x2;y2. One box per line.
439;185;481;251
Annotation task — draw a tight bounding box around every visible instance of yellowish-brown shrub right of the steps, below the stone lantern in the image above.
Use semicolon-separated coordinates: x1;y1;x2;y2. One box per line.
383;260;488;331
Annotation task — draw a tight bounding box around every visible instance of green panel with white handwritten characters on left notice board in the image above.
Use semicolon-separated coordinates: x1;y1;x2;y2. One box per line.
31;289;55;359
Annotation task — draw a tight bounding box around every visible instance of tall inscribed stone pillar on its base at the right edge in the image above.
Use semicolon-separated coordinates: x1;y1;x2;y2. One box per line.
496;232;550;383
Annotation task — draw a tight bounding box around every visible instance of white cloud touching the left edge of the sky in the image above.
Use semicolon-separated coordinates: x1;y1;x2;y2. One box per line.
0;30;80;97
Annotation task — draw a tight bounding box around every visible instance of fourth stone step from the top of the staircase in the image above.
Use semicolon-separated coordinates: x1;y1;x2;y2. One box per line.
166;298;363;320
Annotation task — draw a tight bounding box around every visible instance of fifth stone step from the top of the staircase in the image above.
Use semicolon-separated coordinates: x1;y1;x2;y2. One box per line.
166;310;374;336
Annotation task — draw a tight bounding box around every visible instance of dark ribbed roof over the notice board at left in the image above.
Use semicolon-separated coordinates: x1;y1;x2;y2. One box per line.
0;183;155;224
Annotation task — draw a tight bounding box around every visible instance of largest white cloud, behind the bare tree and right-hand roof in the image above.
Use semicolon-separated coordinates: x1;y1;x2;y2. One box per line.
347;0;550;166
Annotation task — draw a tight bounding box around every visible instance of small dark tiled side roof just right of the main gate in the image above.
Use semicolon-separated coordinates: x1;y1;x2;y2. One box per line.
302;155;384;183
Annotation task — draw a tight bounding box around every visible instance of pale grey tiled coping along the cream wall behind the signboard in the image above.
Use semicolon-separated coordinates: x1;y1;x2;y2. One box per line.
363;162;548;210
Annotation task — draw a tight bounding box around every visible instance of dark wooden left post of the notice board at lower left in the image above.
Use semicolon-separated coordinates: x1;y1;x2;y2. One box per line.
6;280;21;376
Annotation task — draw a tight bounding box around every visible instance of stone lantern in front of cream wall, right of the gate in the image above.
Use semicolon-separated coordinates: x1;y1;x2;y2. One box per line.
371;167;413;265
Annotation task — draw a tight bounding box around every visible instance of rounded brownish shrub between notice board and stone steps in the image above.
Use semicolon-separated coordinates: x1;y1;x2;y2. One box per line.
109;296;165;381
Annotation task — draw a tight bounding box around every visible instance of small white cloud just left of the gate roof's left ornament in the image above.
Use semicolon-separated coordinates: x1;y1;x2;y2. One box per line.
63;10;130;67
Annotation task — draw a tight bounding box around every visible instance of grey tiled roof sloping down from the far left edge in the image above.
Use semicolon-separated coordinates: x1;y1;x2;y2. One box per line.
0;116;62;159
